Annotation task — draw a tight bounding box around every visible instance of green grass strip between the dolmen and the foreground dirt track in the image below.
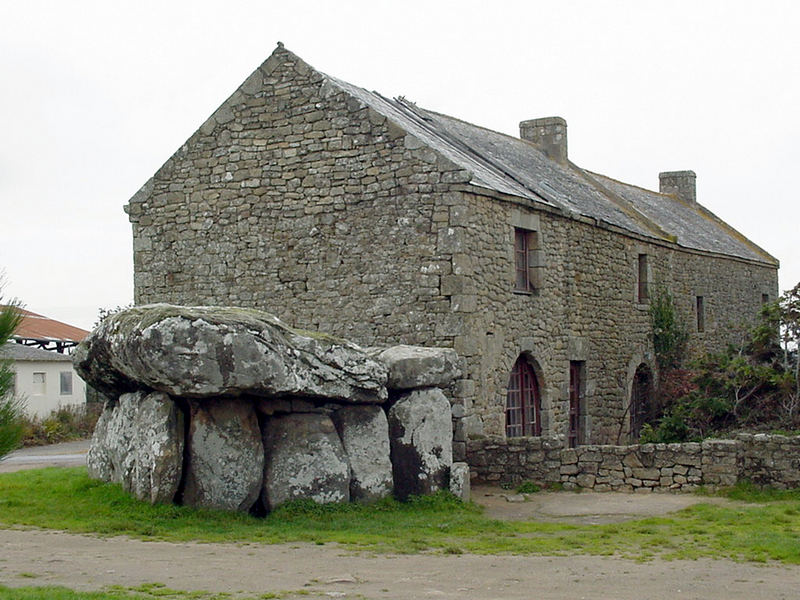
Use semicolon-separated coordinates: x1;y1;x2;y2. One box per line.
0;468;800;564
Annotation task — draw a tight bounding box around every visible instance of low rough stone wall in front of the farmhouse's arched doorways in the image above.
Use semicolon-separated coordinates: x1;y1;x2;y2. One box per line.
467;434;800;492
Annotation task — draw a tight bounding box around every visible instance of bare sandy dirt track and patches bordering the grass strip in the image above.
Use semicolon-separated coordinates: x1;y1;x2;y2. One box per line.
0;447;800;600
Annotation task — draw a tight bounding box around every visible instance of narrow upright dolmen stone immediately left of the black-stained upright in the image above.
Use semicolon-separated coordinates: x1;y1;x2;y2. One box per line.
333;406;394;501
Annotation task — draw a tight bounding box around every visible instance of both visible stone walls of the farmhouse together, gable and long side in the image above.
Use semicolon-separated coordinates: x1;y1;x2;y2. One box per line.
127;48;777;449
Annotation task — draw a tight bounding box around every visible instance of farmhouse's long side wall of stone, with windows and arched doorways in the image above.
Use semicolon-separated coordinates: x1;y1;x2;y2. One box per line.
454;194;777;443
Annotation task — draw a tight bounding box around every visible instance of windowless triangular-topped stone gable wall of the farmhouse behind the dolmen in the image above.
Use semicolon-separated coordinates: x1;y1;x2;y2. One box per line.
127;49;468;347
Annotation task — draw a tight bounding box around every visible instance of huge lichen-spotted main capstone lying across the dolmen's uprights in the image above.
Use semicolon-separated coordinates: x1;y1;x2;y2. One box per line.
74;304;386;403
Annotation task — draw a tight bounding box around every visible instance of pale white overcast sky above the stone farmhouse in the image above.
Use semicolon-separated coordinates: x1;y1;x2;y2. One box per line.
0;0;800;328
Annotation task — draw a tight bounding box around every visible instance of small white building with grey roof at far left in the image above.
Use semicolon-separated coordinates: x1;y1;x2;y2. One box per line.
0;343;86;417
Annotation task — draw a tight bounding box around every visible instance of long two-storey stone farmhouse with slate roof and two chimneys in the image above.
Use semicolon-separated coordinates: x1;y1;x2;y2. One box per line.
126;44;778;460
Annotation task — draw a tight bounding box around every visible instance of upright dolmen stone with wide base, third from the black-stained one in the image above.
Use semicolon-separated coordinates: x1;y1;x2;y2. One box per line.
262;413;350;510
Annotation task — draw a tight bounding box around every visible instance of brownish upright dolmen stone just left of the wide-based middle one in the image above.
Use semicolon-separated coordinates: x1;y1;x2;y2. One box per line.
183;399;264;511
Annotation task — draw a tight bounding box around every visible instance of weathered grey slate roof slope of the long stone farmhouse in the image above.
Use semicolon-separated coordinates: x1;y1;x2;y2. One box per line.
325;75;778;266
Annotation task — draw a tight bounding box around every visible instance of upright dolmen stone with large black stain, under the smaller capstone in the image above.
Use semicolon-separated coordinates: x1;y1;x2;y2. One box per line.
389;388;453;499
